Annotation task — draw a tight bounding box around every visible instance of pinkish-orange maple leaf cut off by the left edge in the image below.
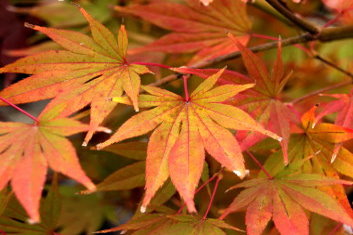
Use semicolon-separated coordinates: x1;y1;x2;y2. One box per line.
0;107;96;222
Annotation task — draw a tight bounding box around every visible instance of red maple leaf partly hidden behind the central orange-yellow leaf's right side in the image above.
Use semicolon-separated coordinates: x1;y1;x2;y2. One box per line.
175;35;298;164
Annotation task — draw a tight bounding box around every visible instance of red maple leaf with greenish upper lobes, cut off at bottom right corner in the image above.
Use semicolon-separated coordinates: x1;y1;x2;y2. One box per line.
220;168;353;235
